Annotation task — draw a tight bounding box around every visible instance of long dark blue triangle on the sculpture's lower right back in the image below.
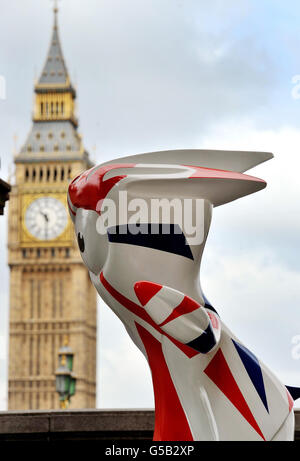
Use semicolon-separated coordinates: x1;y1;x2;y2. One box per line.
232;339;269;413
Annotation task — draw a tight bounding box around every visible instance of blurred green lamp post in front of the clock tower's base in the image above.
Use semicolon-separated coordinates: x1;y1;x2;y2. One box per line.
55;336;76;410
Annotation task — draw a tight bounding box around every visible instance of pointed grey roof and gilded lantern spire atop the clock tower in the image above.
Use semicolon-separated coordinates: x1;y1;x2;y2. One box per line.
17;0;88;161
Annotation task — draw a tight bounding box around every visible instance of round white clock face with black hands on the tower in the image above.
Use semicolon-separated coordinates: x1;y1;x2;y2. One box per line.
25;197;68;240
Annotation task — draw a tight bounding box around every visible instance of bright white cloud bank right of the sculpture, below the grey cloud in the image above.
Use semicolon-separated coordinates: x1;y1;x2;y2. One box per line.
202;122;300;402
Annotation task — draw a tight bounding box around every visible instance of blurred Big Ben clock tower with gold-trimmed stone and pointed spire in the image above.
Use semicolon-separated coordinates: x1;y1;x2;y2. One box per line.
8;7;96;410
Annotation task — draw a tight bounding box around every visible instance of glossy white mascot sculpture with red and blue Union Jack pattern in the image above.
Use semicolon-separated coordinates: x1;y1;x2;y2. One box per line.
68;150;298;441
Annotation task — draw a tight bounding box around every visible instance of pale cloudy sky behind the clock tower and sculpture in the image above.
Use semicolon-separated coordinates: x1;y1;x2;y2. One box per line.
0;0;300;409
